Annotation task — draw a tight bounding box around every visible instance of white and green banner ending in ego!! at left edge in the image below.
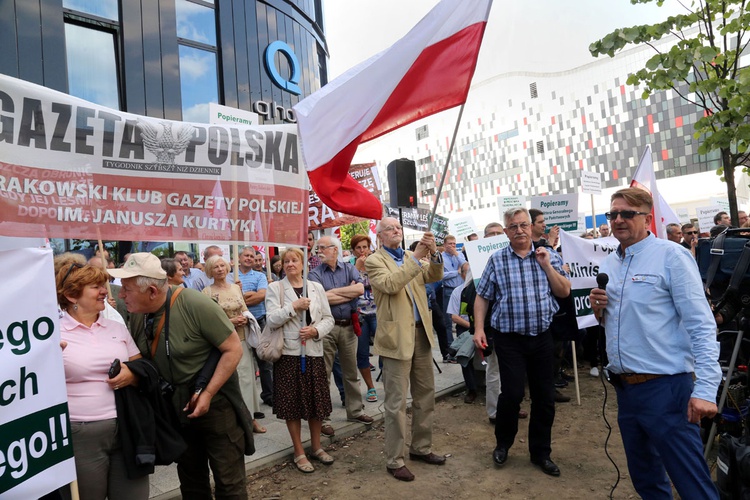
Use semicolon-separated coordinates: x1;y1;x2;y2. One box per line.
0;248;75;500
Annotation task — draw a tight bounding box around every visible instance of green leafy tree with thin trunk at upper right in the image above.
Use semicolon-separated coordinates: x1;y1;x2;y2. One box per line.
589;0;750;225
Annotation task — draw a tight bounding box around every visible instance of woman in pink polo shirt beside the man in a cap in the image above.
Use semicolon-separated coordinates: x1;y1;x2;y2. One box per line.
57;263;149;500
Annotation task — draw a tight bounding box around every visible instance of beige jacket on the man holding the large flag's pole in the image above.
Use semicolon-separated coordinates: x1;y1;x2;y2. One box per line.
365;248;443;359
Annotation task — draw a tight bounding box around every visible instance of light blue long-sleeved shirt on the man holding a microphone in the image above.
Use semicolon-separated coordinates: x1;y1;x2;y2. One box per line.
599;234;721;401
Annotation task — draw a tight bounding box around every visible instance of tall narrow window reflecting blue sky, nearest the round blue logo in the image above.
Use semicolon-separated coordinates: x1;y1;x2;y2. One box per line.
175;0;219;123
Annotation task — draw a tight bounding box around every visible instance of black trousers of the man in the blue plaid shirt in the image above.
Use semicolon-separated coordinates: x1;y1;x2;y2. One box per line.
495;330;555;460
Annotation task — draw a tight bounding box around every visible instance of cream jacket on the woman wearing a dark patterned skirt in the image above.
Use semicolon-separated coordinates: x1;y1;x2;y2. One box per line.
266;278;334;356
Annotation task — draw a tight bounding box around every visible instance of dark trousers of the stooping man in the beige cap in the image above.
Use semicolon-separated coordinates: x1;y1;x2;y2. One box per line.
177;398;247;500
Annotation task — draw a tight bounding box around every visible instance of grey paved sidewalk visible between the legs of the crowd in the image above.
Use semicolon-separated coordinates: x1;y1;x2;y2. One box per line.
151;342;463;500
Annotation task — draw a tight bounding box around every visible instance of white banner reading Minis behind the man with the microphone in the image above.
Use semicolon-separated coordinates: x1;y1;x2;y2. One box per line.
560;231;620;328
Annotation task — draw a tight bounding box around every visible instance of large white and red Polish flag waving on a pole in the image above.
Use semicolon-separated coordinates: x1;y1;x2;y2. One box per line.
294;0;492;220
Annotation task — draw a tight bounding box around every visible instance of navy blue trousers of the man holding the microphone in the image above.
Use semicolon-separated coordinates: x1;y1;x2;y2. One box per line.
616;373;719;500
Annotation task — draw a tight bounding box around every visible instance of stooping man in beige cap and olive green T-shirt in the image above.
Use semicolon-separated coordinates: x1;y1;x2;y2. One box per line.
108;253;254;499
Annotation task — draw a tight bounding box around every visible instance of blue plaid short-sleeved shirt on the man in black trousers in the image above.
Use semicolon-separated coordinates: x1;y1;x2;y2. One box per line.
477;245;567;336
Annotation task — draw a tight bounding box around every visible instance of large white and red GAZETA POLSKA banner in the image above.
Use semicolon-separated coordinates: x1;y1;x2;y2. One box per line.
0;75;309;245
